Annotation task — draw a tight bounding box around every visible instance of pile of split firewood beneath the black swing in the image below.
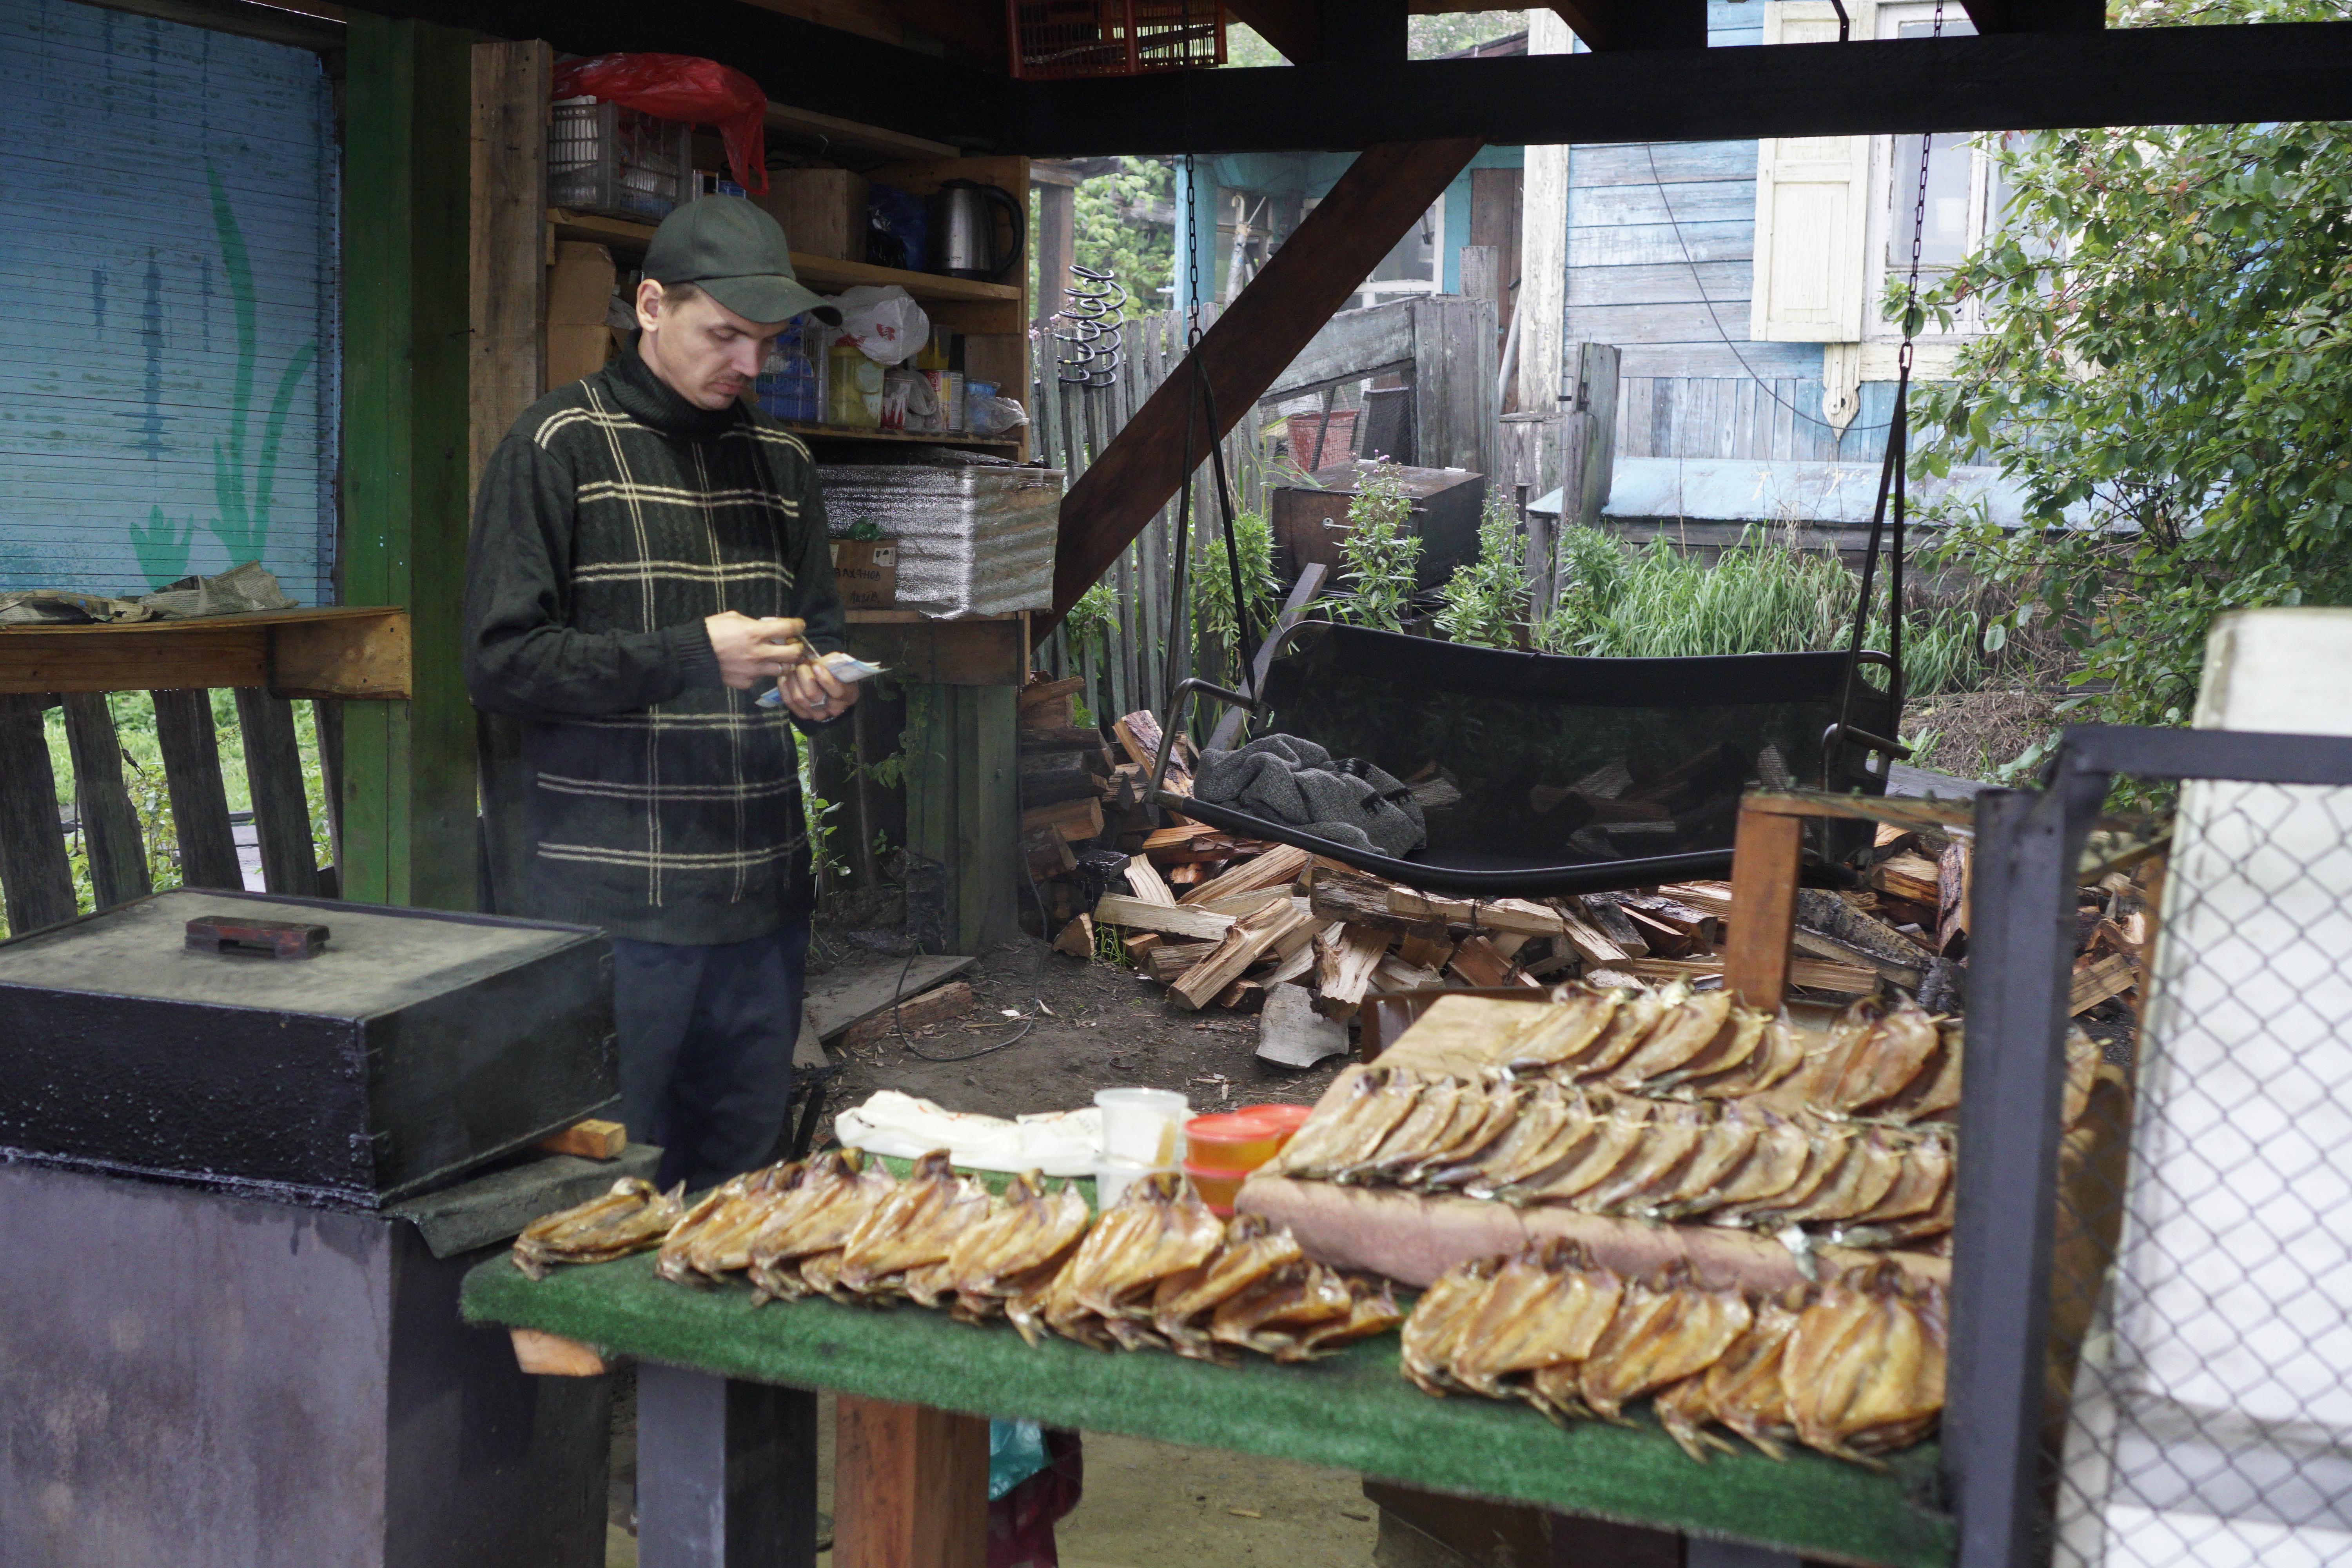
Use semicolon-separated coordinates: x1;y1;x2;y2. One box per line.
1023;724;2161;1042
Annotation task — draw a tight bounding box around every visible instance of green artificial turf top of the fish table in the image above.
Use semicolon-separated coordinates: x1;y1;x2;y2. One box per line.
463;1253;1955;1568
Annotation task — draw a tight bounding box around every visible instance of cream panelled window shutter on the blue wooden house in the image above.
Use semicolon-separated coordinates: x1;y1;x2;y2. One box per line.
1748;0;1877;343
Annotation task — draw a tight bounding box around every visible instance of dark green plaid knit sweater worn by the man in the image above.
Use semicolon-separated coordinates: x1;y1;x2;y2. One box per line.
466;343;847;943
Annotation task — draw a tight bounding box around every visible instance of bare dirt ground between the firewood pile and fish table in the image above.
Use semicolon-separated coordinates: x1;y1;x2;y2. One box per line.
828;938;1345;1142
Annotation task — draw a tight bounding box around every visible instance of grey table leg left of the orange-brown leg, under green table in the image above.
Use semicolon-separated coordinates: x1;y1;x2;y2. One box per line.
637;1361;823;1568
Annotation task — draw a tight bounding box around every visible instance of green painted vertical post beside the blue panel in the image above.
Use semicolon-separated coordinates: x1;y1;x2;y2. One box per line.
341;9;477;910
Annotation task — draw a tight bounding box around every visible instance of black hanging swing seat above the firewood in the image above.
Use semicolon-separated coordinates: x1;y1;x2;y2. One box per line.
1152;621;1900;896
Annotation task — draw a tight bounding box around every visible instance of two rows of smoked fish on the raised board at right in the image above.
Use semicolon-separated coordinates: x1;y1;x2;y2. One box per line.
1268;987;2098;1246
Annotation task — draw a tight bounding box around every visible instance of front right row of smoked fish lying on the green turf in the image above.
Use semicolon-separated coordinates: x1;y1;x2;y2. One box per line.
1402;1239;1950;1465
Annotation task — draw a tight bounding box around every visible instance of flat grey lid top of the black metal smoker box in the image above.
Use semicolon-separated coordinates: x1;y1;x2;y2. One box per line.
0;889;595;1018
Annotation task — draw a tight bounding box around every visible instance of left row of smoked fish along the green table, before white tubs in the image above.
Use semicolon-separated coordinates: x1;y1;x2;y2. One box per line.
515;1150;1404;1361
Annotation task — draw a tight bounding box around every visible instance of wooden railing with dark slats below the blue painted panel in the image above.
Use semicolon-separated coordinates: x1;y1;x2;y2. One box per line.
0;609;409;936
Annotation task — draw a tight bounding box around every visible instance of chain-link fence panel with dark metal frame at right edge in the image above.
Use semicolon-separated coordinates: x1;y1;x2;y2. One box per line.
1947;729;2352;1568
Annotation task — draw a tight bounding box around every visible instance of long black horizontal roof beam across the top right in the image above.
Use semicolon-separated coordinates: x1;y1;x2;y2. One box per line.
1009;21;2352;152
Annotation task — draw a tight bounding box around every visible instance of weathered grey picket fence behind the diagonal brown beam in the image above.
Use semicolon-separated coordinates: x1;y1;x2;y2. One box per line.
1030;308;1282;733
